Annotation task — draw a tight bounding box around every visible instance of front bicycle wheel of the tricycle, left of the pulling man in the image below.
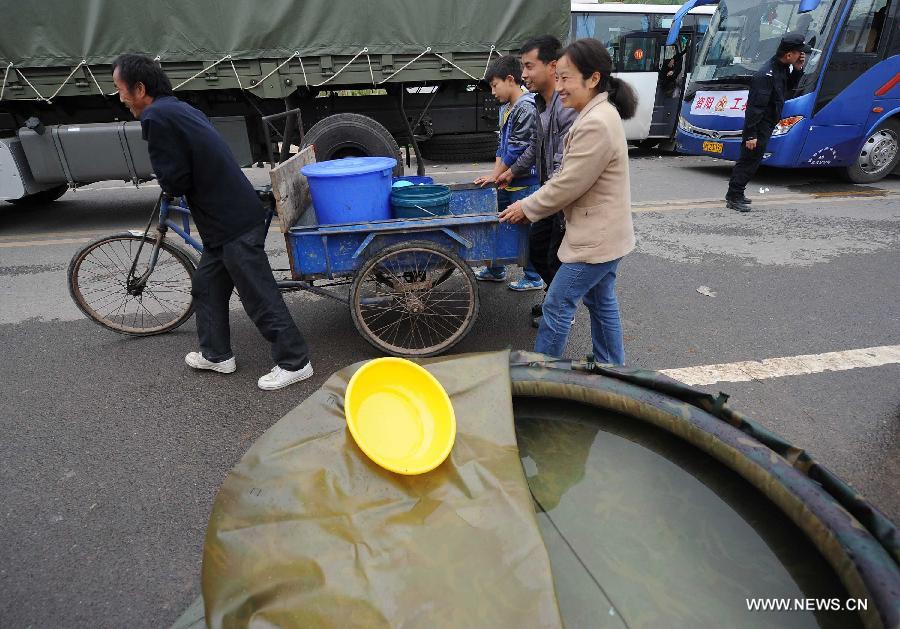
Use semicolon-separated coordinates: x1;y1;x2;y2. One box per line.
69;232;197;336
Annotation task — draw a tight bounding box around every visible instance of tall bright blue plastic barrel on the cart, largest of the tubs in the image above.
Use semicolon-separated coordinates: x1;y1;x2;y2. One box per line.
300;157;397;225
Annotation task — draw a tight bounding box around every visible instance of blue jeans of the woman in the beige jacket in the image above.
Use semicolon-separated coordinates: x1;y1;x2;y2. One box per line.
534;258;625;365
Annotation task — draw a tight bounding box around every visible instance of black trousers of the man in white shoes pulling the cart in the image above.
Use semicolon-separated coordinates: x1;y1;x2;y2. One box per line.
191;223;309;371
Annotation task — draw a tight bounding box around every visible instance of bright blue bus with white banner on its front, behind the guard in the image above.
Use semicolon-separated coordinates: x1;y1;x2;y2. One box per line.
669;0;900;183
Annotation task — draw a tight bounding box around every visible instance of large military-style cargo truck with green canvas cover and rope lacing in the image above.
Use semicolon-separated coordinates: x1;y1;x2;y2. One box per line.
0;0;570;204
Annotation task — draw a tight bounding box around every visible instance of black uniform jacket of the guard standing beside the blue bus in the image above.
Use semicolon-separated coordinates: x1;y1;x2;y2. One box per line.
744;57;803;142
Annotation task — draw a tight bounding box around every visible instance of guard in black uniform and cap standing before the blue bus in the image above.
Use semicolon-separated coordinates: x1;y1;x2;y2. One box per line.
725;33;812;212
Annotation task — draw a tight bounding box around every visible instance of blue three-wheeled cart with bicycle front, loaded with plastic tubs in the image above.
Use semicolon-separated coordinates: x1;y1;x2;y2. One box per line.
69;162;528;356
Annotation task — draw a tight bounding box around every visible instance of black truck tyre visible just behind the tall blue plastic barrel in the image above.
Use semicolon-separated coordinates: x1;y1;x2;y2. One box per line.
303;114;403;177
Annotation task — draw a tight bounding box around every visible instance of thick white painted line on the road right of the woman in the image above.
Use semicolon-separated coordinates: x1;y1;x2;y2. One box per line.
660;345;900;385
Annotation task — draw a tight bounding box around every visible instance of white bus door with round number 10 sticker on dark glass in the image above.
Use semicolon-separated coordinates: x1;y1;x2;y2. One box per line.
617;32;661;141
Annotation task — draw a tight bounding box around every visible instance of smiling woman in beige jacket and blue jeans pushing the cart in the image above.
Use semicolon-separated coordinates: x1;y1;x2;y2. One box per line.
500;39;637;365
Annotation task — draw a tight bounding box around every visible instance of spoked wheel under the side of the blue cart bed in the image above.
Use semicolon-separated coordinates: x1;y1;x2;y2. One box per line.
350;241;478;356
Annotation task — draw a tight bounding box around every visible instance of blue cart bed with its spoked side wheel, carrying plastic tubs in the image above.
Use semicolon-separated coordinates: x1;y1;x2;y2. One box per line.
281;185;528;356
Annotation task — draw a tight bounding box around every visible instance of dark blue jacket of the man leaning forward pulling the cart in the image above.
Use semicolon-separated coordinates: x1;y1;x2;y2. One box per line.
141;96;265;247
